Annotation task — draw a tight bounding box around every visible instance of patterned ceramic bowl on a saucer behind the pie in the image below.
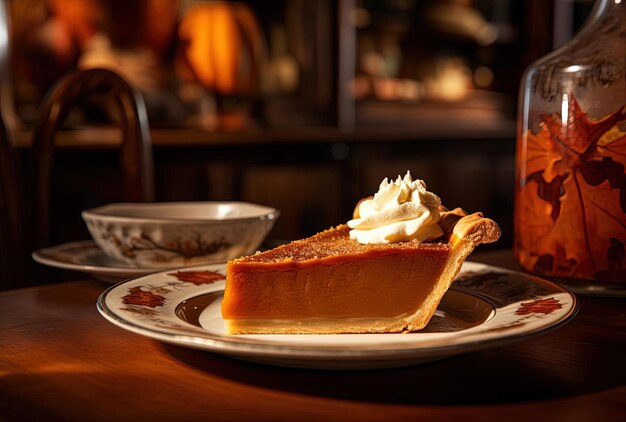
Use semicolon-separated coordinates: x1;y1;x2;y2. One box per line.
82;202;280;268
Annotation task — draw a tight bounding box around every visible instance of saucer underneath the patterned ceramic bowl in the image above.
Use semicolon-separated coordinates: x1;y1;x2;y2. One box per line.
33;240;160;283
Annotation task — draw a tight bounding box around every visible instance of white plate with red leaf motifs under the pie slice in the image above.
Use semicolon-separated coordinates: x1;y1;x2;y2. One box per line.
98;262;578;369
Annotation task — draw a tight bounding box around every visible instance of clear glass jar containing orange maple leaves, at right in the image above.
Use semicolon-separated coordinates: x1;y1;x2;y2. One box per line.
514;0;626;295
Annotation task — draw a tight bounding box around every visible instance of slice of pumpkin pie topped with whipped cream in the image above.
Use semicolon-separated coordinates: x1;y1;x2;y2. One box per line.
222;173;500;334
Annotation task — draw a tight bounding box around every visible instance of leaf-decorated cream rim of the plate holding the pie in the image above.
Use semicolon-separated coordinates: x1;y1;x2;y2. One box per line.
97;262;579;360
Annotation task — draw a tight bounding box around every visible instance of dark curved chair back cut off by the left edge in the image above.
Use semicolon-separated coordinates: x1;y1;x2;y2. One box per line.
0;109;26;290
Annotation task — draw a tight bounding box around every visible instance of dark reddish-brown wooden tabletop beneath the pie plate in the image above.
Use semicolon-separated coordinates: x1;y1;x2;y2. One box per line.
0;251;626;421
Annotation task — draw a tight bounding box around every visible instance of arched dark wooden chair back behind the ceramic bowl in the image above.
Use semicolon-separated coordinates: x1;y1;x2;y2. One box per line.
32;69;154;248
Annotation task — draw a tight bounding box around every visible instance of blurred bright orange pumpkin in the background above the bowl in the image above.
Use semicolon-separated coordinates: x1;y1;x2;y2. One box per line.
178;1;266;95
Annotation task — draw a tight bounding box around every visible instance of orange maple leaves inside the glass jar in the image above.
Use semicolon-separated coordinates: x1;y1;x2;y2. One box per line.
516;95;626;281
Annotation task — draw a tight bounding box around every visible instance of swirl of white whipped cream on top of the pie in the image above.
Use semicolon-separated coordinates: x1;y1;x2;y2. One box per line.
348;171;443;243
